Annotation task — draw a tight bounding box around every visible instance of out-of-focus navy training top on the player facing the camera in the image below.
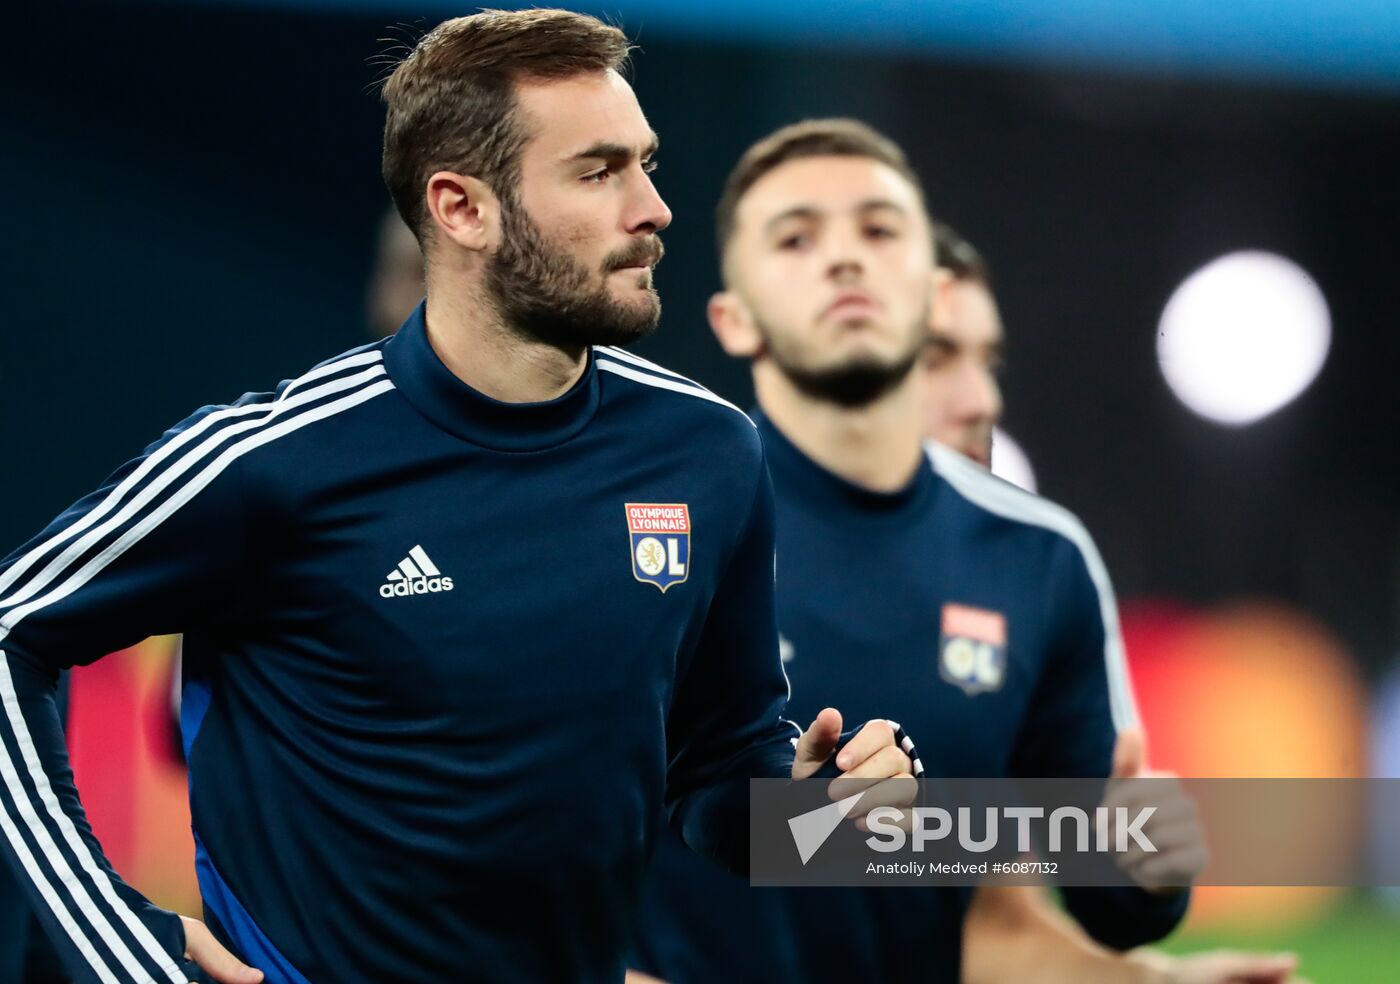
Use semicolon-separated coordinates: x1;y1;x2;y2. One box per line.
633;414;1187;984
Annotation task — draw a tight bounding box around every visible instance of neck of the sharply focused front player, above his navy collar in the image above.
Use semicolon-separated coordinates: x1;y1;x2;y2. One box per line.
426;287;588;403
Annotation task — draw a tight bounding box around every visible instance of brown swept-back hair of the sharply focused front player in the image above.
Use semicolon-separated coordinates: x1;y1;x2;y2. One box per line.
381;10;631;242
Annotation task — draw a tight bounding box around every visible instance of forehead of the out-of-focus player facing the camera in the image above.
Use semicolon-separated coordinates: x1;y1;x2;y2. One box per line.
735;155;923;234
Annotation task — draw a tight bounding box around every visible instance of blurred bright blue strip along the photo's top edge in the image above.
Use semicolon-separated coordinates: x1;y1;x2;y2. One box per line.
144;0;1400;90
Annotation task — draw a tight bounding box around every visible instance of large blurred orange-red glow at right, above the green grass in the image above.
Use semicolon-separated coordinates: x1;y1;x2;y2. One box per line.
1121;600;1368;932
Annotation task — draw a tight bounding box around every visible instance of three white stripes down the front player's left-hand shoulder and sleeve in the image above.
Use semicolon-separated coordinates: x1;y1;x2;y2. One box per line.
0;350;393;984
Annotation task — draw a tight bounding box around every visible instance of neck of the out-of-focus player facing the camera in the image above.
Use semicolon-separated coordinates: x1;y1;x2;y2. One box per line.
753;363;924;493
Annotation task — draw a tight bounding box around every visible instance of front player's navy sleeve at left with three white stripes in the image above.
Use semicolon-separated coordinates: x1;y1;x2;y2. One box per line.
0;396;257;984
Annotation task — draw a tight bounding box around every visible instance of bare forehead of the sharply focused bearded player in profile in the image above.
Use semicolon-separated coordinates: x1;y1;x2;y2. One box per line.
515;70;657;162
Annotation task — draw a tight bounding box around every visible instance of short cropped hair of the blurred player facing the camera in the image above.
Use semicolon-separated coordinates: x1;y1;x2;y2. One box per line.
714;119;924;262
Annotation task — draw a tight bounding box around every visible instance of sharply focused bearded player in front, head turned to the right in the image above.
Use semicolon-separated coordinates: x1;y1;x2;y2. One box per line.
0;10;909;984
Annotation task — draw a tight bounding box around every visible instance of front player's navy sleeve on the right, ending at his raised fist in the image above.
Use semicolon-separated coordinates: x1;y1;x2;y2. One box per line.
666;442;801;872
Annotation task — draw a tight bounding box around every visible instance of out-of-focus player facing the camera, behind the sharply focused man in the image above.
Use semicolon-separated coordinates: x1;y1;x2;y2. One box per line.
636;120;1197;984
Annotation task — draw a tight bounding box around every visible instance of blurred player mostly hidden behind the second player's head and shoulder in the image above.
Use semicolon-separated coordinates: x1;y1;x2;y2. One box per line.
920;223;1296;984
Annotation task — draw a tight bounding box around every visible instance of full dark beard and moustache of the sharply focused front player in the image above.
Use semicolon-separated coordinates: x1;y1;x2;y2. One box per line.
486;195;664;349
